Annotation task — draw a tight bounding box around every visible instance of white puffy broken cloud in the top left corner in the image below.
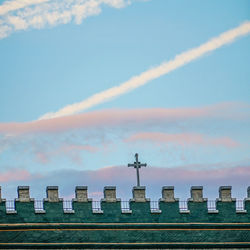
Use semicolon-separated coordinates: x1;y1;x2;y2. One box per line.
0;0;130;39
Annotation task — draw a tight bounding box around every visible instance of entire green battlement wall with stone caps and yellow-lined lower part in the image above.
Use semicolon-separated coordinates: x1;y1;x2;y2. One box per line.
0;186;250;249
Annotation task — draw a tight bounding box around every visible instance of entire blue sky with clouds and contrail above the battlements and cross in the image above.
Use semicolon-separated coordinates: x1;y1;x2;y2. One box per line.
0;0;250;200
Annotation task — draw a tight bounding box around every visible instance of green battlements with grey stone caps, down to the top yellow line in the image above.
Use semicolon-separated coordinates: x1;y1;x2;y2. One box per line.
0;186;250;223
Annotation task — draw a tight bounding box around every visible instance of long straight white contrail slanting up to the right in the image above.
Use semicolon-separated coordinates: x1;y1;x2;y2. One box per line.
39;21;250;120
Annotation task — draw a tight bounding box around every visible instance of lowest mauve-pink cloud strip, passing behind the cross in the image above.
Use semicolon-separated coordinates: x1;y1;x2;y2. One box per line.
85;165;250;182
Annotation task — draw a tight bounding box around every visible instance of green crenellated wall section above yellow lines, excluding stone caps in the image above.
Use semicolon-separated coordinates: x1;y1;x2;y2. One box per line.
0;200;250;224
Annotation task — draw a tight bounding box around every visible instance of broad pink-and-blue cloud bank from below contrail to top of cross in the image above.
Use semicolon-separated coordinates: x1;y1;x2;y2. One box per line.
0;103;250;172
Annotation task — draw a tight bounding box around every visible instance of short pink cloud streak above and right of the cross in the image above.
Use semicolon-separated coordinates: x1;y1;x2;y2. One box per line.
125;132;240;147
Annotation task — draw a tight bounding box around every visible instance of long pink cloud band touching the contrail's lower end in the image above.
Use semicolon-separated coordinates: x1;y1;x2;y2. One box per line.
0;103;249;136
